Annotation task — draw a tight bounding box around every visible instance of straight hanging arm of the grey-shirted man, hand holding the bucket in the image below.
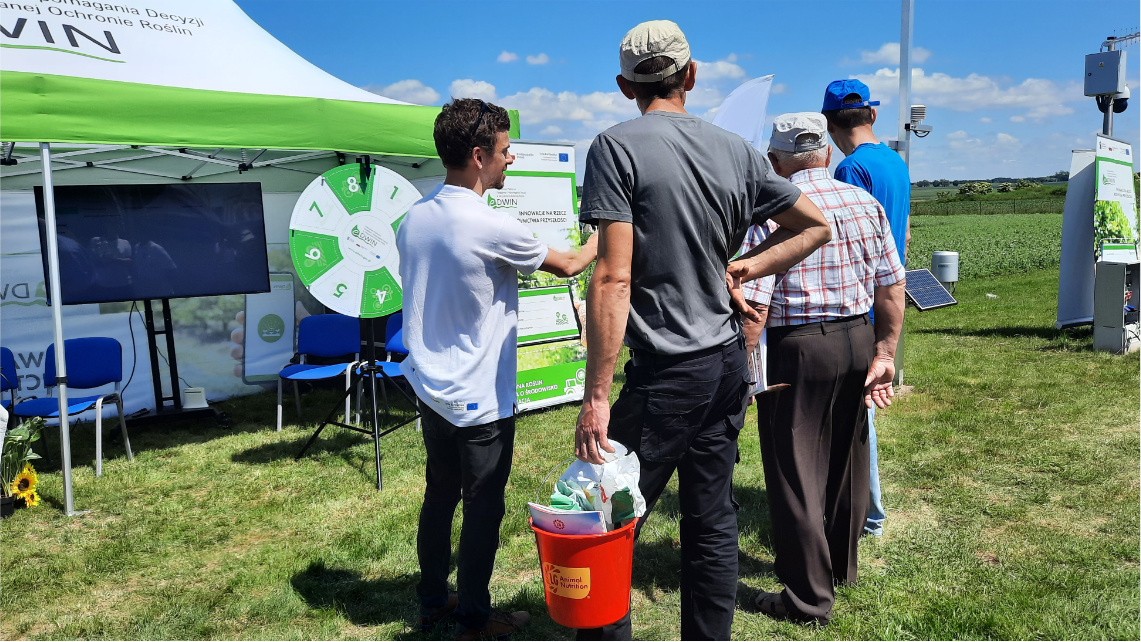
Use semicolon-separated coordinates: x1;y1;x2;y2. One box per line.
574;220;634;464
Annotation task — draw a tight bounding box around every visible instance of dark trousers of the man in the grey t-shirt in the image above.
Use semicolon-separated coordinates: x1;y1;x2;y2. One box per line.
578;338;747;640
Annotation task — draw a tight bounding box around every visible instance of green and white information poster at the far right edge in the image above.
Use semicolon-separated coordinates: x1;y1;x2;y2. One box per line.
1093;136;1141;260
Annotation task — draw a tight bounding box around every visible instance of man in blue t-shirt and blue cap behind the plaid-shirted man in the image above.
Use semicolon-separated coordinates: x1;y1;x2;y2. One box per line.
820;79;912;535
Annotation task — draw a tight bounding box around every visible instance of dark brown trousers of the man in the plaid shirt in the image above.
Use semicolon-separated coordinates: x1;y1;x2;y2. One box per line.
758;315;875;623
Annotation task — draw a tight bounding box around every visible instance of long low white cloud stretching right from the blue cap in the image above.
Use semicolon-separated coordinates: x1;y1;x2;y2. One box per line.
853;67;1083;121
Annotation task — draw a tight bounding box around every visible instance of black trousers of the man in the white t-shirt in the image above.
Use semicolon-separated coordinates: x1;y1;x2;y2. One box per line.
416;403;515;628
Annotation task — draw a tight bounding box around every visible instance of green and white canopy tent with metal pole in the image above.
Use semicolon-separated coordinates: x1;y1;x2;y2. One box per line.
0;0;518;514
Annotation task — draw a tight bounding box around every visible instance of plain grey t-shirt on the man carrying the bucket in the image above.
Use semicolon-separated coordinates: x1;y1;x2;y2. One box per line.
578;112;800;355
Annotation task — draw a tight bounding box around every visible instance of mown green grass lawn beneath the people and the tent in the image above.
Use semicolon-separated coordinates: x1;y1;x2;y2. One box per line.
0;270;1141;640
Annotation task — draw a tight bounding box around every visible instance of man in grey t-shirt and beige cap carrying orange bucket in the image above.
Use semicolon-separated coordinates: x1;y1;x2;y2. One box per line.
575;21;831;640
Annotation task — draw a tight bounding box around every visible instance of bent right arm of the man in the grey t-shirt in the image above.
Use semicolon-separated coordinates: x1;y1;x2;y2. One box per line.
728;194;832;317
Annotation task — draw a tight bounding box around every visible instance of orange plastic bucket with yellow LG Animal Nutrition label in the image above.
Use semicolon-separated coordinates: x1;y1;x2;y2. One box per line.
527;518;638;628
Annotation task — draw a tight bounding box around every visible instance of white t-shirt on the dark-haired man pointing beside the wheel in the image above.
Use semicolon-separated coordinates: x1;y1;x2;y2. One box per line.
396;185;547;425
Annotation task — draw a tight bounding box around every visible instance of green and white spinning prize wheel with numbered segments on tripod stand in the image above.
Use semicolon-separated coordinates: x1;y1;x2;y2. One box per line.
289;164;420;318
